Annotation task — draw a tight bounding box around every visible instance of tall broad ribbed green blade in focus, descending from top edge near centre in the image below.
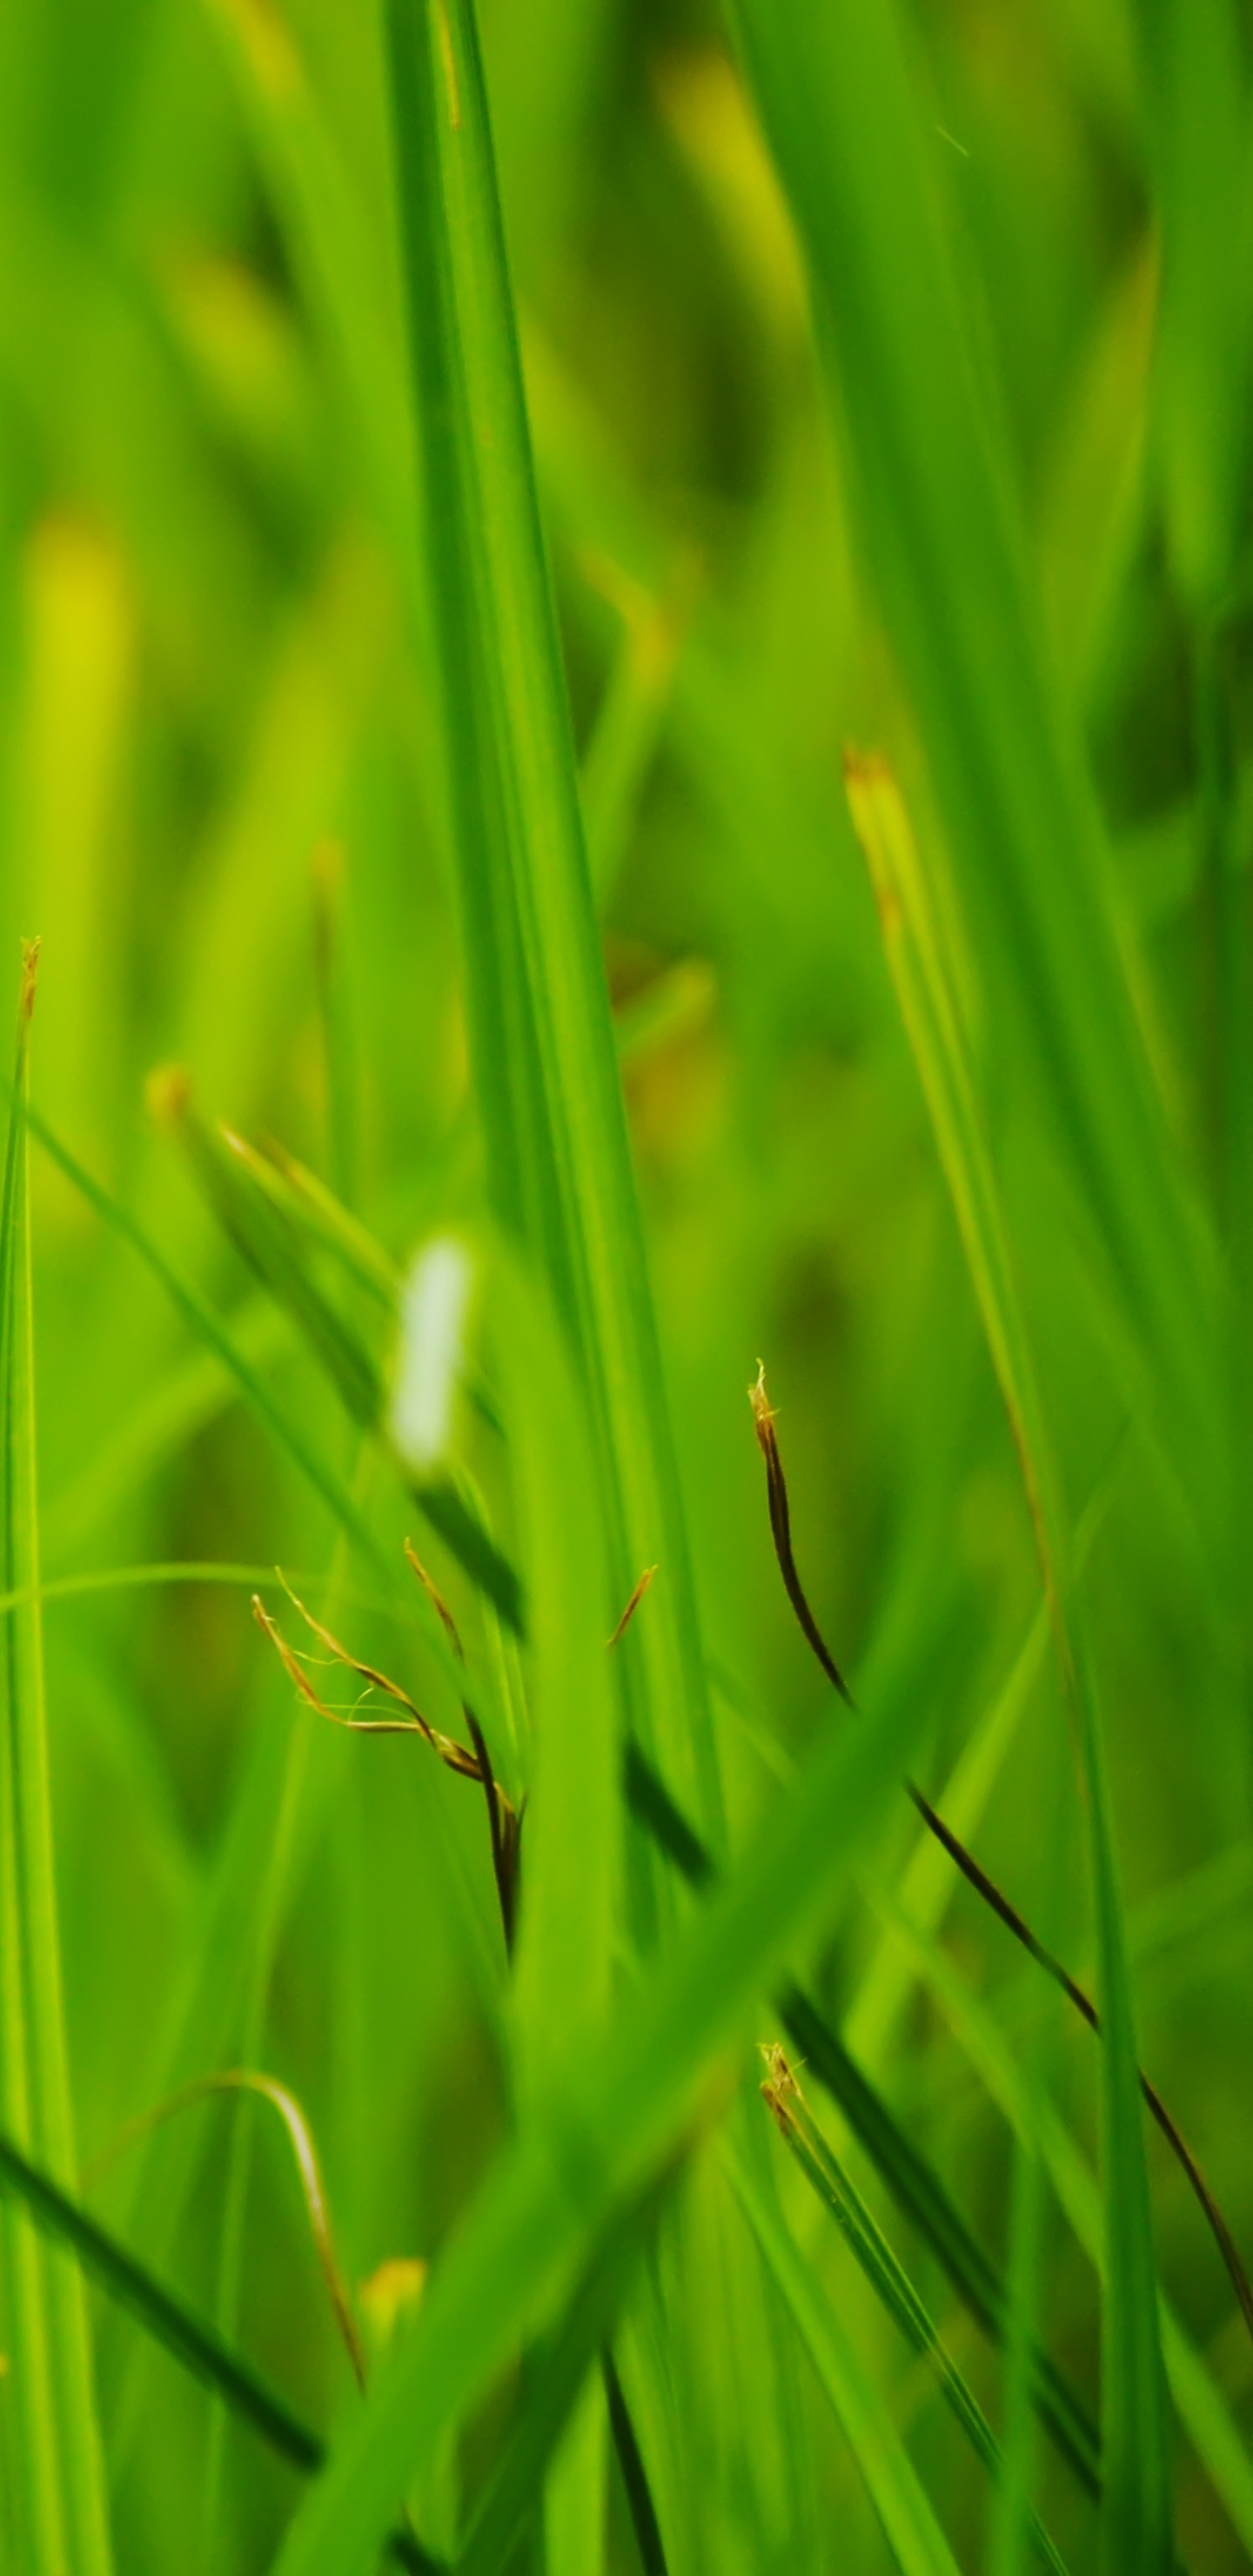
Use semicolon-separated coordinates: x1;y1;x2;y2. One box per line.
376;0;720;1821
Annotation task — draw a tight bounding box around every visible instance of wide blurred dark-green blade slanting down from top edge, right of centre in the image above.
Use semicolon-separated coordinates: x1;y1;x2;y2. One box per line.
734;0;1219;1522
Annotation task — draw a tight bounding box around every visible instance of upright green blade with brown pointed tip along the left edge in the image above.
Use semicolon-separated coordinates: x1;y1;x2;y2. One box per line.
0;948;111;2576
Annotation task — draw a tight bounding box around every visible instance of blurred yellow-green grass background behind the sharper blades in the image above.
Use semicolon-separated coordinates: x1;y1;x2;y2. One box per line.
0;0;1253;2576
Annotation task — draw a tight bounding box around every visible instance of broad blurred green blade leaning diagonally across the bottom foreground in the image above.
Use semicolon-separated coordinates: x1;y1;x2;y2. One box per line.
278;1587;938;2576
